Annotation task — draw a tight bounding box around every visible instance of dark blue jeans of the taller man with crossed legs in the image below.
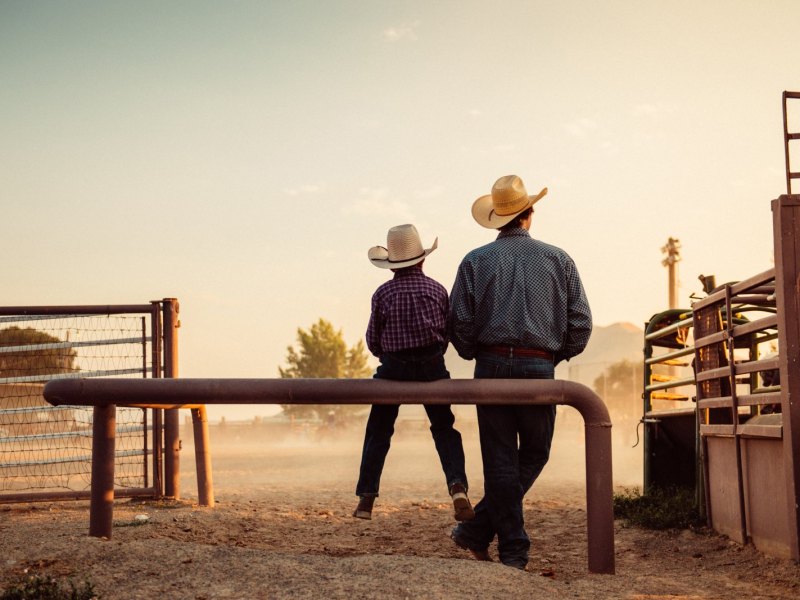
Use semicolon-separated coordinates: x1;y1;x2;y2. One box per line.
454;352;556;566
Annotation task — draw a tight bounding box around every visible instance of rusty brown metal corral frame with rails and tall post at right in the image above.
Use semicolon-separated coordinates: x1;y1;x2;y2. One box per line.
694;260;800;560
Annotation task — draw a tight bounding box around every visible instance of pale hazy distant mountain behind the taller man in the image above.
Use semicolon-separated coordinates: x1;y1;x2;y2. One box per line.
445;323;644;387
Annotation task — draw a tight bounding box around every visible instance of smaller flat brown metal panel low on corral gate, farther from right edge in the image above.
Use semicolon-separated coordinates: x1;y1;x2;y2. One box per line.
706;436;745;544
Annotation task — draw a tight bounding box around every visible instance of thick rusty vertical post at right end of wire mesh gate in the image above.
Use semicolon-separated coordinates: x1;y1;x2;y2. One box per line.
161;298;181;500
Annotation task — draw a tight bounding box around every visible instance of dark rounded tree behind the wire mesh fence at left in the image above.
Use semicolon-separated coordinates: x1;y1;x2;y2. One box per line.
0;327;76;377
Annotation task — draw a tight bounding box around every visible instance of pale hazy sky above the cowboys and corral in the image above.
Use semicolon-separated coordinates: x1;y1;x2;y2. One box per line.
0;0;800;412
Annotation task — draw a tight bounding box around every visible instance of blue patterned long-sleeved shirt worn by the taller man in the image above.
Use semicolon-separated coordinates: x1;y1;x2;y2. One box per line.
448;228;592;363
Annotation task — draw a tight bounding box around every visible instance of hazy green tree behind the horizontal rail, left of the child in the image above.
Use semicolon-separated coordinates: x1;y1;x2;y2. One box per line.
278;319;372;420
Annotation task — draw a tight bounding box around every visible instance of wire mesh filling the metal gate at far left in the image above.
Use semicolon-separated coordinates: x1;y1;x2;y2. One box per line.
0;314;153;499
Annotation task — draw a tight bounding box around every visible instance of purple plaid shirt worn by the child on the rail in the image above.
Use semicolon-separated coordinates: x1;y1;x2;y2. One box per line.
367;267;450;358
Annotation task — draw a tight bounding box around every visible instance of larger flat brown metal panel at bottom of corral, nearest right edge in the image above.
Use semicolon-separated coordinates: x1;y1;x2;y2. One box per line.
742;438;791;558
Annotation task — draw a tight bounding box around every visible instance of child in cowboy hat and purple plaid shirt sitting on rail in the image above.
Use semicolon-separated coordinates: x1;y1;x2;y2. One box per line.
353;225;475;521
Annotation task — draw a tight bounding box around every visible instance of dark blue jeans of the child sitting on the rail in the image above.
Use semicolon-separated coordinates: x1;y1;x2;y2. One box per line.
356;346;467;496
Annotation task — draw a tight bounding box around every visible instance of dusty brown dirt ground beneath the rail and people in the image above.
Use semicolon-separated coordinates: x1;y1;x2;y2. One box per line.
0;423;800;600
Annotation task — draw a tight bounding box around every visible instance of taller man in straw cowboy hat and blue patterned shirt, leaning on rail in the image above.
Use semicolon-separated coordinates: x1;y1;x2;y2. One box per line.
448;175;592;569
